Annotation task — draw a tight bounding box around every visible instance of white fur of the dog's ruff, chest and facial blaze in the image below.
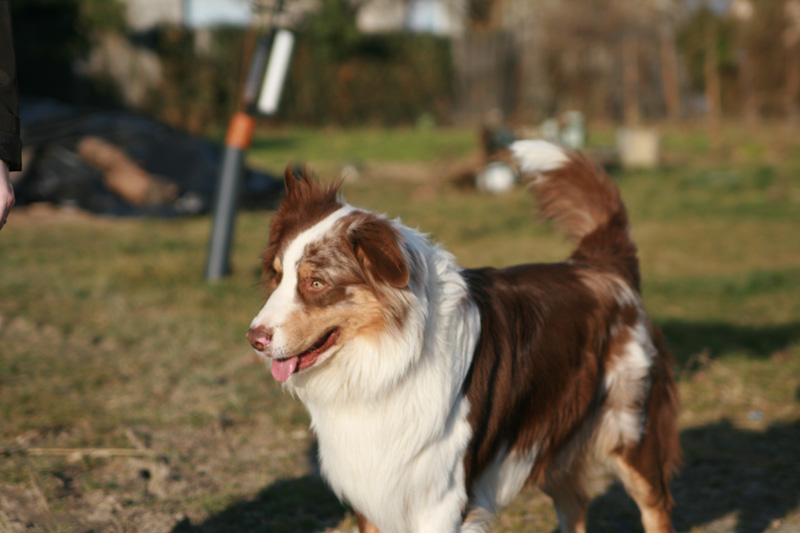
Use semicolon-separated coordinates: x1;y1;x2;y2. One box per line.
253;208;480;533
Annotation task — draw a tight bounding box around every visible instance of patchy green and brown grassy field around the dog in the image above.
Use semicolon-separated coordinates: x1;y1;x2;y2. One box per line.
0;122;800;533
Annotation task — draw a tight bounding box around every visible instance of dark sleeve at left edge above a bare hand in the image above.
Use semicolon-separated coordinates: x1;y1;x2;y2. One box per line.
0;0;22;170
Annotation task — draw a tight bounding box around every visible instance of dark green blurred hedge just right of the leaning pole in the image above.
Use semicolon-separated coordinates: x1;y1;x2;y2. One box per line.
280;32;452;125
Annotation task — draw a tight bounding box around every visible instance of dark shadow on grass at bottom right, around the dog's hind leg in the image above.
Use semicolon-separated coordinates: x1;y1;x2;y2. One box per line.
589;421;800;533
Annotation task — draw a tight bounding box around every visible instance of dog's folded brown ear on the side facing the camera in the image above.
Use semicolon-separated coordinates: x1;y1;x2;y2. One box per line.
349;218;410;289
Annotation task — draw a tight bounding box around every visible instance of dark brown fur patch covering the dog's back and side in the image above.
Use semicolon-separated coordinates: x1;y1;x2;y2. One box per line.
464;264;614;486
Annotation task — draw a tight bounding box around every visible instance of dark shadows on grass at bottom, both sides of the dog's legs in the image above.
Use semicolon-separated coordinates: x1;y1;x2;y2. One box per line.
172;421;800;533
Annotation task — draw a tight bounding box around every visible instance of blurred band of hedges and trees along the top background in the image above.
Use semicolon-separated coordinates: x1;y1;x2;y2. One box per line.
13;0;800;133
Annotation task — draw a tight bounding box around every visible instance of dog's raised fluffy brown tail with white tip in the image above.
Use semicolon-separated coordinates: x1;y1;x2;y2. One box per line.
511;140;640;291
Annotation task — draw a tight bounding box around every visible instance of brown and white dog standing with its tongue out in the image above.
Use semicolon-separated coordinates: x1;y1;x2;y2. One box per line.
247;141;680;533
